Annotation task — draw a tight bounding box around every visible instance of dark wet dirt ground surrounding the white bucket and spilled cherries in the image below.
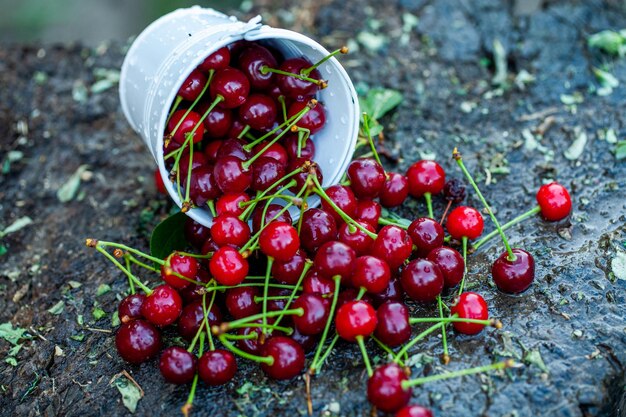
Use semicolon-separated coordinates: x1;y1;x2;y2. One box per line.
0;0;626;417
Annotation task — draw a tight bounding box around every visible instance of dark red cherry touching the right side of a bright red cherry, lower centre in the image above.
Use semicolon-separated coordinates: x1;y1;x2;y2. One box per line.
374;301;411;347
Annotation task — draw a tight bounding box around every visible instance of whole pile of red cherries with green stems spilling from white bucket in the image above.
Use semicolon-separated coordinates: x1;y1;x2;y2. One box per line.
87;39;572;417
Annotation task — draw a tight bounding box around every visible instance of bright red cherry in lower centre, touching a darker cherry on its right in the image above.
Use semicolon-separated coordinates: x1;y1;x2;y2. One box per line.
335;300;378;342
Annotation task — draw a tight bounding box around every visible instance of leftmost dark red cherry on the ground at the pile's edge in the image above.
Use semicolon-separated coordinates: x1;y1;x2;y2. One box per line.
115;320;161;363
